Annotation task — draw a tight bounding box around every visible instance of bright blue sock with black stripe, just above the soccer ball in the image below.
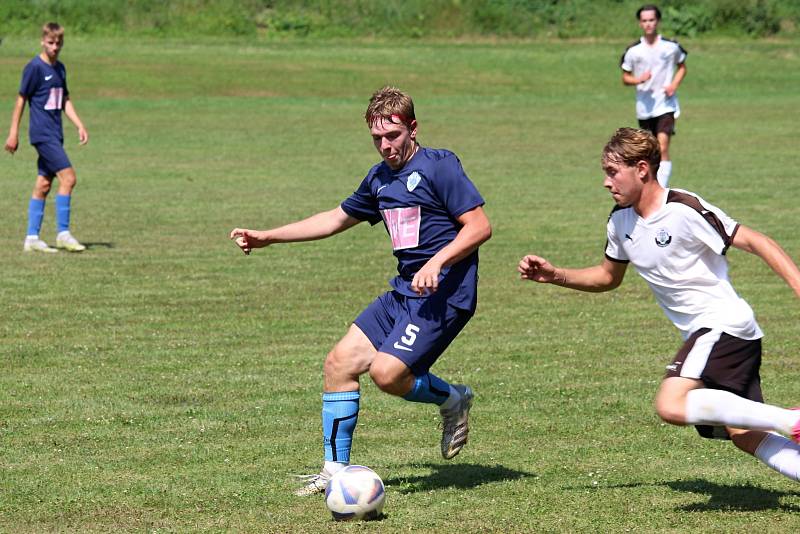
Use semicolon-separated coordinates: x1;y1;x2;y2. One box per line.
322;391;361;463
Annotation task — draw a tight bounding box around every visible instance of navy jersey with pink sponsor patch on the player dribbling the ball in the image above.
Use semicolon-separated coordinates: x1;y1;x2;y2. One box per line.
342;148;484;309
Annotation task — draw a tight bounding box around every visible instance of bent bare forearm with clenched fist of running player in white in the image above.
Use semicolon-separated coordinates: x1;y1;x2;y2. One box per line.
517;254;628;293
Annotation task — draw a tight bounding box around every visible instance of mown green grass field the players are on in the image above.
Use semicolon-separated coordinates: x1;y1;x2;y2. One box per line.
0;35;800;532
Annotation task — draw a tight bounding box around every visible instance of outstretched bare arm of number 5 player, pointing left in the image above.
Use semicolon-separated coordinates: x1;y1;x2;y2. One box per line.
230;206;361;254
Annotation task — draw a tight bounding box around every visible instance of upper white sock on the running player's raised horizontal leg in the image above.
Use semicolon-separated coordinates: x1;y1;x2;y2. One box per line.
686;388;800;435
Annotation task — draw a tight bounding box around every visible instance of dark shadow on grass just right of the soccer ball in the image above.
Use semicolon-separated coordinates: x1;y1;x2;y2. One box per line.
384;463;535;493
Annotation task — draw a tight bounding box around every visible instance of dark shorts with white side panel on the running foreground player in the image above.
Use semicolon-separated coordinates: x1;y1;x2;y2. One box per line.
665;328;764;439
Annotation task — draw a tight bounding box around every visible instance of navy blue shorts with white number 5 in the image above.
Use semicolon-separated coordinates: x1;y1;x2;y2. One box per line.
353;291;472;376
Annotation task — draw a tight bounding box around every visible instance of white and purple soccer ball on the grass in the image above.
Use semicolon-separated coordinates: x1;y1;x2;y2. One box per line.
325;465;386;521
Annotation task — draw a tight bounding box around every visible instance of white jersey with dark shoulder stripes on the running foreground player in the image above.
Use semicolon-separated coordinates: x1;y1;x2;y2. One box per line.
606;189;763;339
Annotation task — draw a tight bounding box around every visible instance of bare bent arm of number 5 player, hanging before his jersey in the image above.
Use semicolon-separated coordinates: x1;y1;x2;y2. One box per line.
411;206;492;296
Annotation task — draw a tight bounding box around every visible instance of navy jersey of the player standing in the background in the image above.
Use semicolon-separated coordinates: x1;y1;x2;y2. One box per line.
19;56;69;144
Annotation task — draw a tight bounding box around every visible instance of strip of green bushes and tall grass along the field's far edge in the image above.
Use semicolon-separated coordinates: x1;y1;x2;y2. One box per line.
0;0;800;38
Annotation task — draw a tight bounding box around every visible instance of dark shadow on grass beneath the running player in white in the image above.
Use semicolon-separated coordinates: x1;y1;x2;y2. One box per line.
608;479;800;512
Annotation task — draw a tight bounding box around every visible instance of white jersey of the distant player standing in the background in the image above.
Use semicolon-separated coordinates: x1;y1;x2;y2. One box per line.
620;35;687;119
